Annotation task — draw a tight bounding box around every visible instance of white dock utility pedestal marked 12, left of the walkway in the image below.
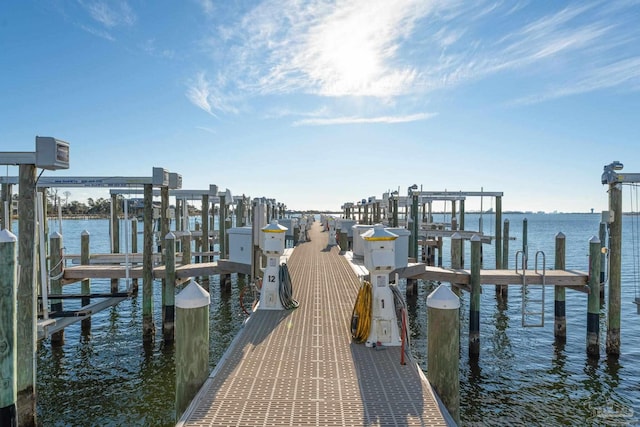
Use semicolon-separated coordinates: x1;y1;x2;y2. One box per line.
258;220;287;310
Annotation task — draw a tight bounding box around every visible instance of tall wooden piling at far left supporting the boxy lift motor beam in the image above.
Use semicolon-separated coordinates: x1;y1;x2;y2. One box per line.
16;165;37;427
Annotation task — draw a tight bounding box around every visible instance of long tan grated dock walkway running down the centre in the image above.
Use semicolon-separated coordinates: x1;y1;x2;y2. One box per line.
177;223;448;426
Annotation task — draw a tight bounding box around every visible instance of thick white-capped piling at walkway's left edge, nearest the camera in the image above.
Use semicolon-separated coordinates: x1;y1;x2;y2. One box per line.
175;280;211;419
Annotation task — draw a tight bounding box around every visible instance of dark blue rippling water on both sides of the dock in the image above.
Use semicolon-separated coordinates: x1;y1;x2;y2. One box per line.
37;214;640;426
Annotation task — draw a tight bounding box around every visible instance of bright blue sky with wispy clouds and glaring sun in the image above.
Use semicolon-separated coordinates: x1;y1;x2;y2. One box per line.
0;0;640;212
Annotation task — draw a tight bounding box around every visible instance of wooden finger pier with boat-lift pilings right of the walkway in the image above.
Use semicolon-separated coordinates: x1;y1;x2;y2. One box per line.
341;187;620;358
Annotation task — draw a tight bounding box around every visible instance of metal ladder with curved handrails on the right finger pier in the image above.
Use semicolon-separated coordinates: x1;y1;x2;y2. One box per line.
516;251;547;328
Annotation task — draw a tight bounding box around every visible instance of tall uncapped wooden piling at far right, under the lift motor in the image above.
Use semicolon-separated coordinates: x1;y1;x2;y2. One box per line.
607;183;622;355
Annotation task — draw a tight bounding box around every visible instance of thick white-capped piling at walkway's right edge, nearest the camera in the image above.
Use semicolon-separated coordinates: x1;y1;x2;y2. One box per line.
427;285;460;424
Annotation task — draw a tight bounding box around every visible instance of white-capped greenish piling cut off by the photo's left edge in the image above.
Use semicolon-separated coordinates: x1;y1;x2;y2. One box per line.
0;228;18;427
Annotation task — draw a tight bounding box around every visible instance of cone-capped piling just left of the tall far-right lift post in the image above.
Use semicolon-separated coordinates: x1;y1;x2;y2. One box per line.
587;236;600;357
